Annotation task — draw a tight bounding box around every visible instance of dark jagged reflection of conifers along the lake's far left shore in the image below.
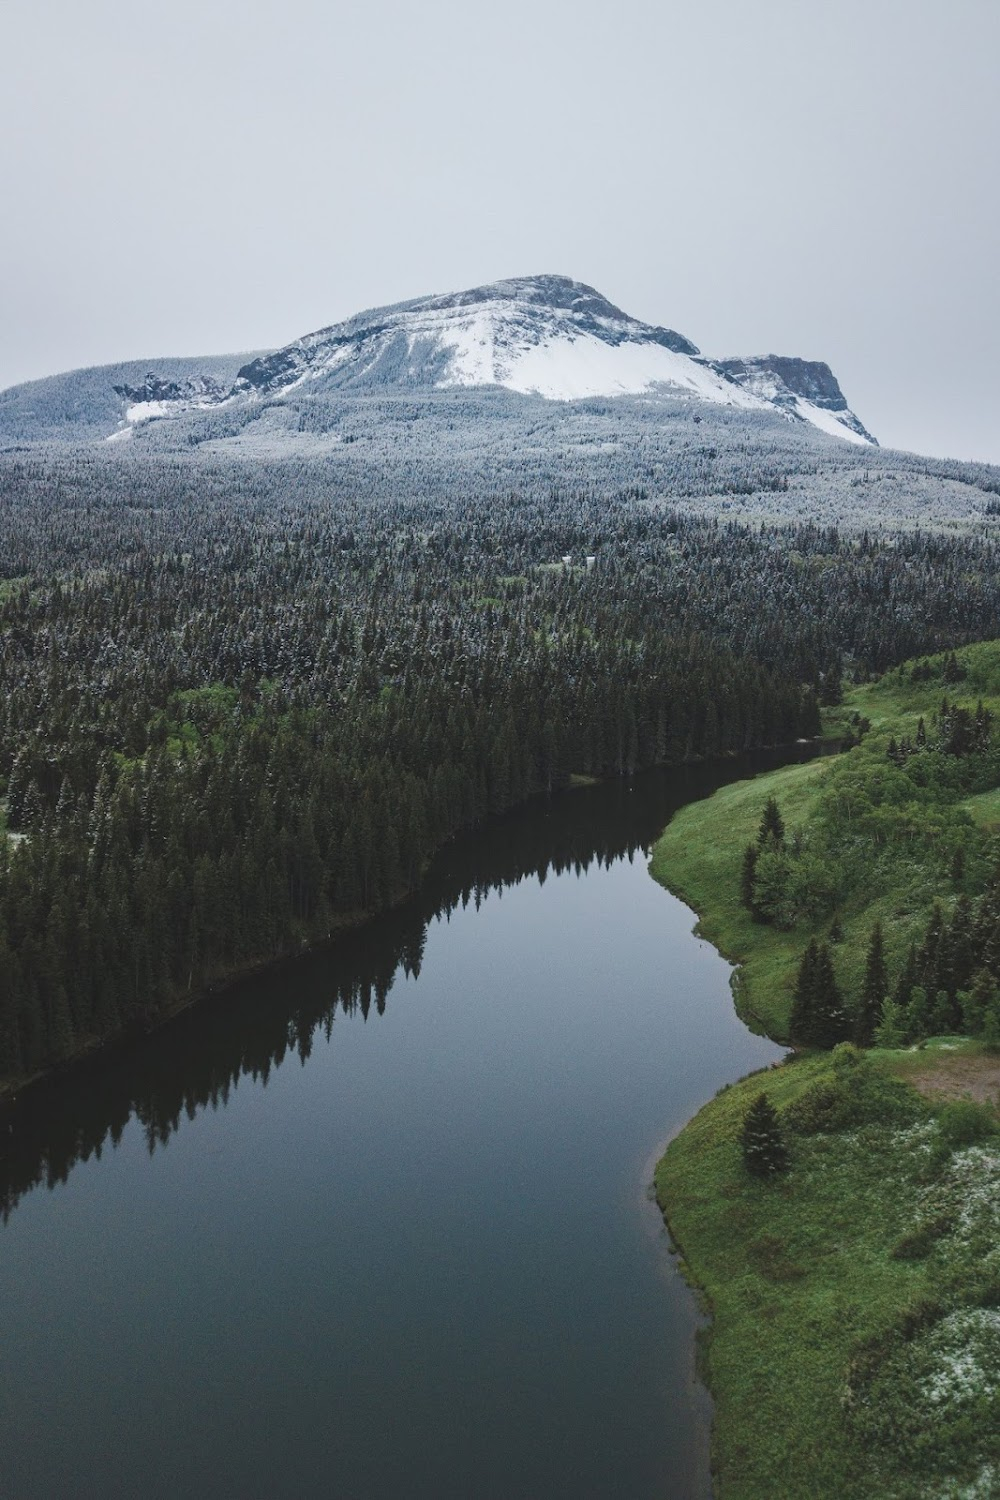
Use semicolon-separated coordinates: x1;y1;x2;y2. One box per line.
0;747;814;1221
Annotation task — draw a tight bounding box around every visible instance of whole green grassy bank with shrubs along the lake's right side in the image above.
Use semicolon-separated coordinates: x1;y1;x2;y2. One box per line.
651;642;1000;1500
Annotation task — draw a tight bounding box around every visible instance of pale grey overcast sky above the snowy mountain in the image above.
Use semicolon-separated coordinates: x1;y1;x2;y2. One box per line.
0;0;1000;462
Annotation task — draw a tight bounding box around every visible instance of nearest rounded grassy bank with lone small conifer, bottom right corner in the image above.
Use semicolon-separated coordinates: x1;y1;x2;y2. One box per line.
657;1049;1000;1500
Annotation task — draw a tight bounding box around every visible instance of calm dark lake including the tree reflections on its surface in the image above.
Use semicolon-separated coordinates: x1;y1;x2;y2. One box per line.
0;759;797;1500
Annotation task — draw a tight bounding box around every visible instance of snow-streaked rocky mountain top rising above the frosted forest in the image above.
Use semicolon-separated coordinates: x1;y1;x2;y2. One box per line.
0;276;876;446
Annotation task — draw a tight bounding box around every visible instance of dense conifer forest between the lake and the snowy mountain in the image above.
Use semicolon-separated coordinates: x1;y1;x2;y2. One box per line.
0;459;1000;1080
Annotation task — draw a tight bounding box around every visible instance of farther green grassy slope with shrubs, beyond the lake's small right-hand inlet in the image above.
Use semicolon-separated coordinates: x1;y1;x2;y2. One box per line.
651;642;1000;1040
